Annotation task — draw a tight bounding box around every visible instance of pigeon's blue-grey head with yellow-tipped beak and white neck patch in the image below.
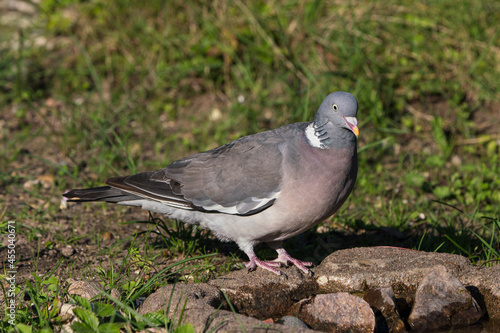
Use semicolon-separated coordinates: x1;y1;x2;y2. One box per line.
306;91;359;149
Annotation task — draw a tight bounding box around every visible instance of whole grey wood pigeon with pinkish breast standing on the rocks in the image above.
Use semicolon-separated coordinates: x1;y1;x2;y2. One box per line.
64;92;358;274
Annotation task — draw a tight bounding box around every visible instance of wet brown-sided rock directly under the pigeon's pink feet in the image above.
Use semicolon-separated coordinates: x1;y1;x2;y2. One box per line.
208;267;316;319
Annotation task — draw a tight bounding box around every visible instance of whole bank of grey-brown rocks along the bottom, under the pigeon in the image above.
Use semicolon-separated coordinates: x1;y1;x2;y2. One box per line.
59;247;500;332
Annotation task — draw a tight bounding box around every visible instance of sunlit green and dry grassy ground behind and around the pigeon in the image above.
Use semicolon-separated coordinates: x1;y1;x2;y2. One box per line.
0;0;500;330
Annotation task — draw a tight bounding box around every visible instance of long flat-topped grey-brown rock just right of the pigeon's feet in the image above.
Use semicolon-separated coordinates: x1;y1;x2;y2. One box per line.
315;247;471;304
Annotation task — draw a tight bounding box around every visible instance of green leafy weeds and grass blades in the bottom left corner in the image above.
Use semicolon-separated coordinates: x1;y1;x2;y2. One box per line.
0;254;213;333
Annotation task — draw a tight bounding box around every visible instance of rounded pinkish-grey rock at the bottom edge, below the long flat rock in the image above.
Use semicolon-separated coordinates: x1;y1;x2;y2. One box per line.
296;293;375;333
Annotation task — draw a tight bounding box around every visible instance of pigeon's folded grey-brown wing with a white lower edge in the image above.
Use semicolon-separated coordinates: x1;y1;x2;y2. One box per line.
149;130;285;215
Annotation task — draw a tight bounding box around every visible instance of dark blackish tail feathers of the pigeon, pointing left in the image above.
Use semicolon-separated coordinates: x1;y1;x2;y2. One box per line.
63;186;142;203
